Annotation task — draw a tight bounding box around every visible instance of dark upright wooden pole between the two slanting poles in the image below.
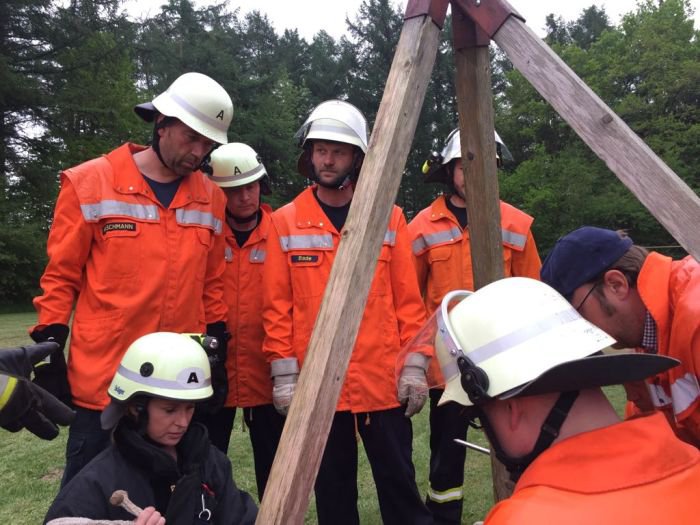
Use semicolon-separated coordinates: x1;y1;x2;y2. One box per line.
452;11;513;502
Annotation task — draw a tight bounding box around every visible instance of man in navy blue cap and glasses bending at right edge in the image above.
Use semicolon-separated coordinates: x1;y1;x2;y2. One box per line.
542;226;700;447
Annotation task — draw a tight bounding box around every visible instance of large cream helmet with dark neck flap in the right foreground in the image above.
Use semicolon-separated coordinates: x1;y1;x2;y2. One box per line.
407;277;678;406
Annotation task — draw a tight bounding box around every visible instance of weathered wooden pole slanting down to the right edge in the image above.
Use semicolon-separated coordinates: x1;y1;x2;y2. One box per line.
493;17;700;260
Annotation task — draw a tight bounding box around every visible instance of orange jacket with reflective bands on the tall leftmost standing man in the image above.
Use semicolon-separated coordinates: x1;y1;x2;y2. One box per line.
32;144;226;410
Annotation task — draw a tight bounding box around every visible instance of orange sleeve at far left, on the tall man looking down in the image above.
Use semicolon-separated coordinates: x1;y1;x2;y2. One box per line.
30;175;93;331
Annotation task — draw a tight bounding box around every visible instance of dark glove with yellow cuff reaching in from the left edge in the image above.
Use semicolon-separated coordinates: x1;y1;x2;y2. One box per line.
0;342;75;439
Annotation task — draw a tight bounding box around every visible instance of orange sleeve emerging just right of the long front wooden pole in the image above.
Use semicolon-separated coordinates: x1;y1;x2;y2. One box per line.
390;213;425;352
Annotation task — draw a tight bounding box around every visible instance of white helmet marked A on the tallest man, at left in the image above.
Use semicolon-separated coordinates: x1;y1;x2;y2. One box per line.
134;73;233;144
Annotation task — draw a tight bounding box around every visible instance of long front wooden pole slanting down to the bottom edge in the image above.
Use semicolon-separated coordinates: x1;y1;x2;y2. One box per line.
256;16;440;525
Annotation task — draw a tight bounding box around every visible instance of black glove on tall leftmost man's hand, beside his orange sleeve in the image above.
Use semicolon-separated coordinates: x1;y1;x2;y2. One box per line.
29;324;72;405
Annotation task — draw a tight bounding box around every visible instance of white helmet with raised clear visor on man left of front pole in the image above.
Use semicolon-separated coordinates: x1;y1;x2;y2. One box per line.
294;100;369;153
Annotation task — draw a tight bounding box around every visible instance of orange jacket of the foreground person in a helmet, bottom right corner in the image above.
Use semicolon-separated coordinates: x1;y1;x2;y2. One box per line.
484;414;700;525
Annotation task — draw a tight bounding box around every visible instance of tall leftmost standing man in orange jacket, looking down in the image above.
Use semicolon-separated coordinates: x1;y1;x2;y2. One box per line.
30;73;233;485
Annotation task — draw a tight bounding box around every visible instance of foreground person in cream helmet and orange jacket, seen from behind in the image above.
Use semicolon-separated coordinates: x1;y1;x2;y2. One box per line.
416;277;700;525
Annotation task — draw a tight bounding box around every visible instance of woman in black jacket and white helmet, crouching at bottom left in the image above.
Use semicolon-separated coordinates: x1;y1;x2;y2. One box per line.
46;332;257;525
